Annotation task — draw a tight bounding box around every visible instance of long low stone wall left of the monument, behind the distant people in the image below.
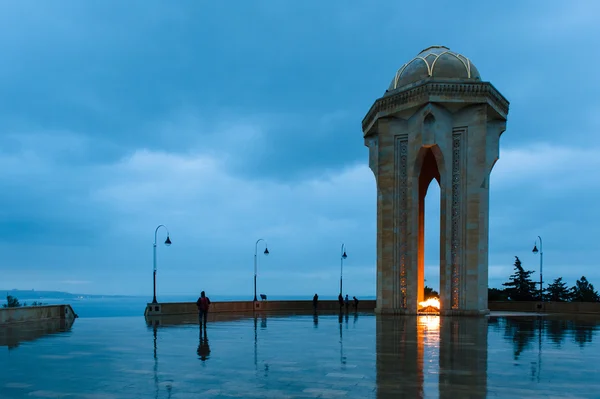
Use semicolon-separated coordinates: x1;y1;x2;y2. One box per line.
144;300;375;316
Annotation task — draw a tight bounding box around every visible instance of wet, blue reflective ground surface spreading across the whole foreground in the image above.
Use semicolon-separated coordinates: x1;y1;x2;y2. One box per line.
0;313;600;399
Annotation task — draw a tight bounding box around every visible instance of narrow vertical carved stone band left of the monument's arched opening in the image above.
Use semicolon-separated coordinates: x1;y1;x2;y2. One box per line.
394;135;408;309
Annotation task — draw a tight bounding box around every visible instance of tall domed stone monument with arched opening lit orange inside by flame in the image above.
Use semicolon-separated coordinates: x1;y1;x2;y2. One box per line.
362;46;508;315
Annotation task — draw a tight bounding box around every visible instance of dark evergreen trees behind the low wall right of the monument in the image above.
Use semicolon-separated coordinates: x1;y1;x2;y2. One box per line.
488;256;600;302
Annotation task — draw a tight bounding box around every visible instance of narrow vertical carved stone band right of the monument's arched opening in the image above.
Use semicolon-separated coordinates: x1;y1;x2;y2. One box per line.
450;131;463;309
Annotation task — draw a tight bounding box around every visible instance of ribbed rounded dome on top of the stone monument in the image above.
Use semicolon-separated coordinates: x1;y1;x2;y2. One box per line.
388;46;481;91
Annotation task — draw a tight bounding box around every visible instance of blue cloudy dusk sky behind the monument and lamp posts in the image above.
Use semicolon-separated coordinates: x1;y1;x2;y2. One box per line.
0;0;600;296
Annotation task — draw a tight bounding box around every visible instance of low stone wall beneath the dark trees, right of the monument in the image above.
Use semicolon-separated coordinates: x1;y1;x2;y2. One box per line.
488;301;600;315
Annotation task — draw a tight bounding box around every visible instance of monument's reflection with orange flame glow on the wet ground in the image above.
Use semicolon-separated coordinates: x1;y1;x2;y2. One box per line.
376;316;488;398
